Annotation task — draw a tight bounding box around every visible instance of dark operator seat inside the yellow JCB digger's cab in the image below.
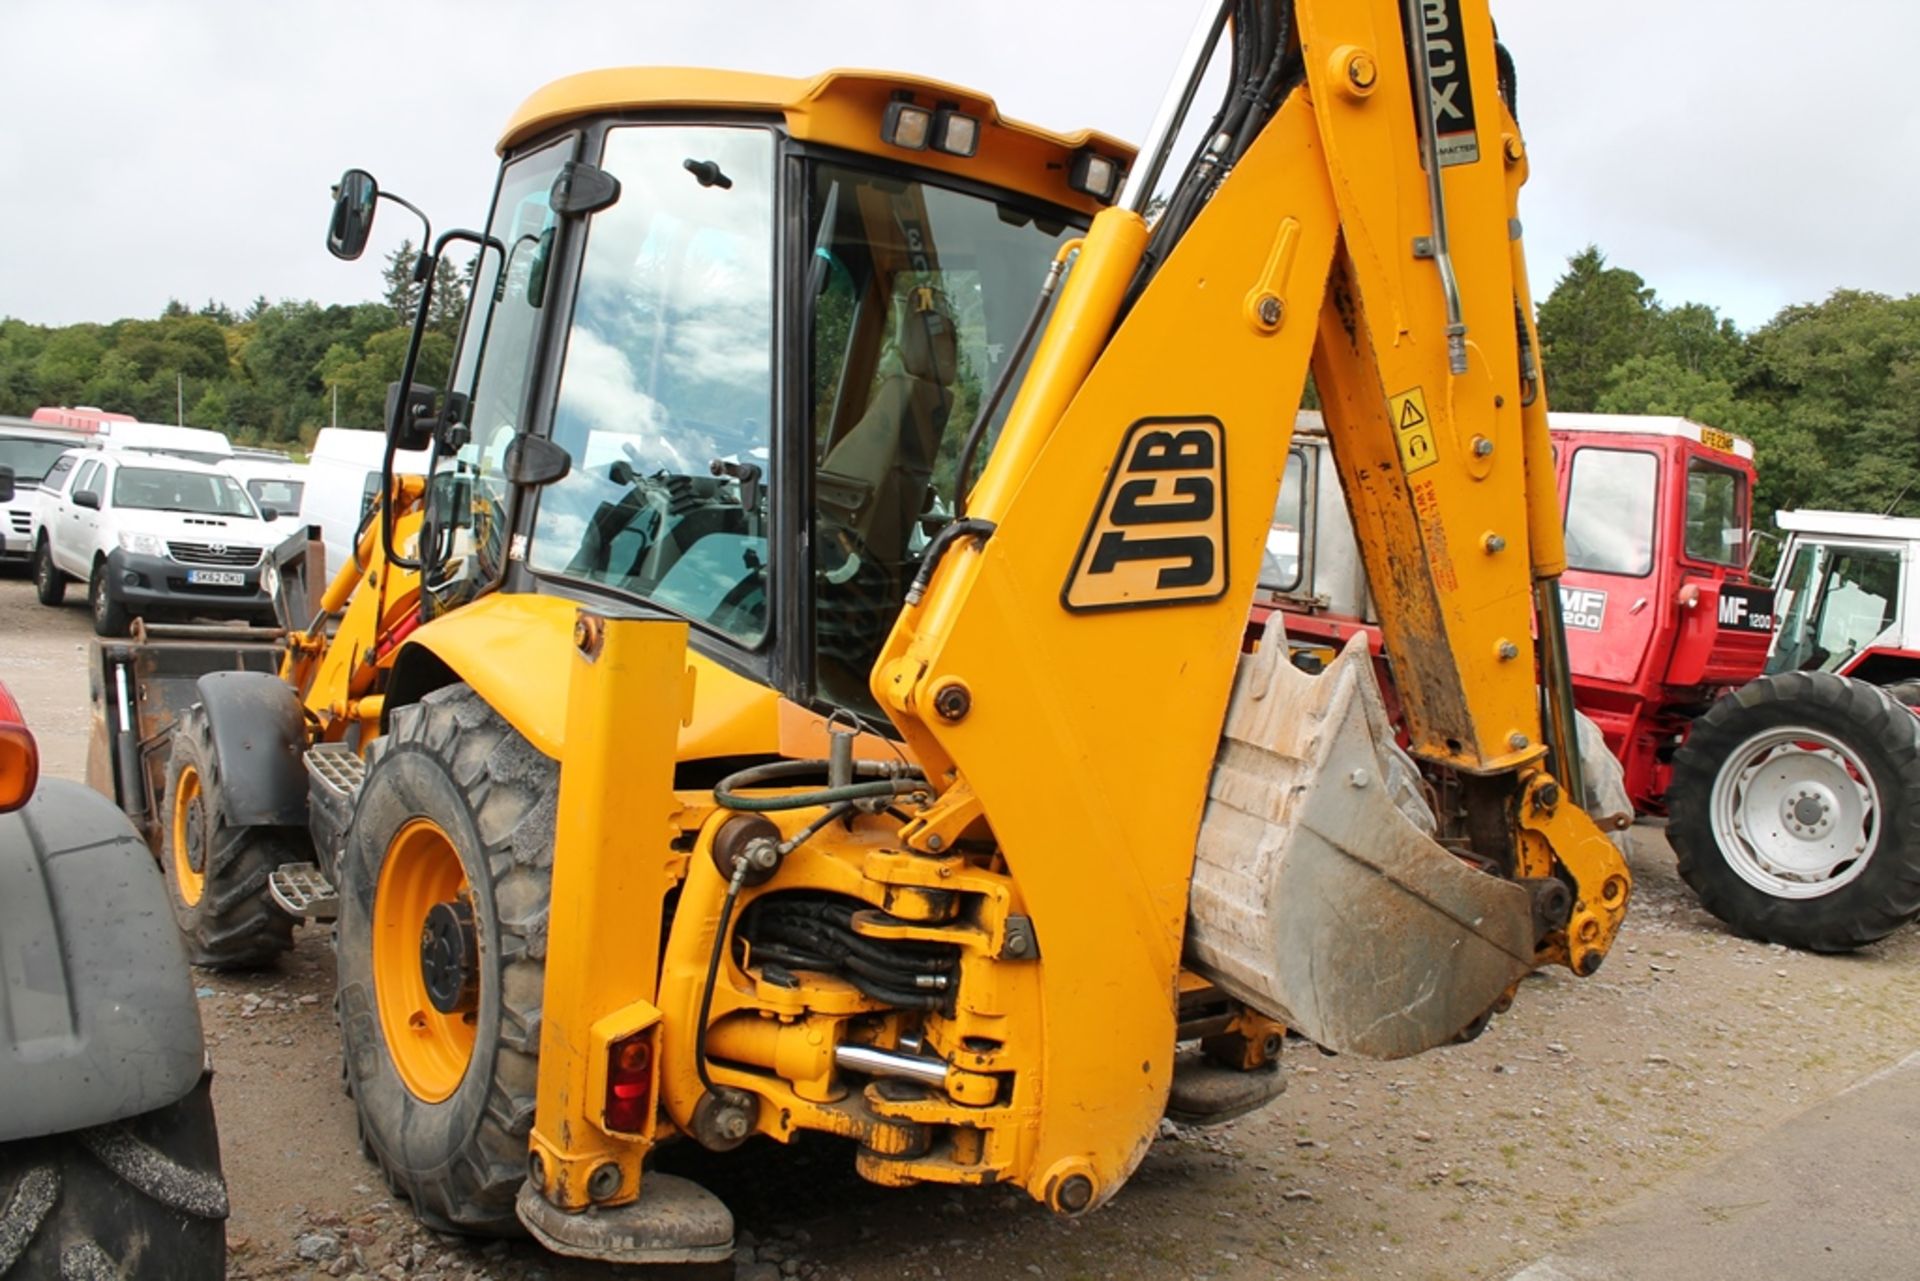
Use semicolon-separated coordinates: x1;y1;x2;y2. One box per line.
816;286;958;567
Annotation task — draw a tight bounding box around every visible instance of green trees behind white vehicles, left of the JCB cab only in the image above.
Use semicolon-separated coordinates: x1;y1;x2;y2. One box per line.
0;242;467;446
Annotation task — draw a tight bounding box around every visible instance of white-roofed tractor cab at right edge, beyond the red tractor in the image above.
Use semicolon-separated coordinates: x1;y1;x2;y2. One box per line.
1766;511;1920;686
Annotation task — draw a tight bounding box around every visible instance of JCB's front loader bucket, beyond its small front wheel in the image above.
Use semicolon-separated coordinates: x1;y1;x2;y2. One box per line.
86;526;324;855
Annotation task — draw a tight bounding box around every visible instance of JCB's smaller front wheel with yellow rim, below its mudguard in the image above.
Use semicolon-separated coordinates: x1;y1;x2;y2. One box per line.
159;703;303;970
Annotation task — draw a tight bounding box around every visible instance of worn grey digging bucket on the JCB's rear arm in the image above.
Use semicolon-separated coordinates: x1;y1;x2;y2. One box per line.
1187;636;1534;1058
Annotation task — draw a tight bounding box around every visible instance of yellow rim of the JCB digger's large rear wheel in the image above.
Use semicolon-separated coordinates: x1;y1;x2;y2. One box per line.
372;818;474;1102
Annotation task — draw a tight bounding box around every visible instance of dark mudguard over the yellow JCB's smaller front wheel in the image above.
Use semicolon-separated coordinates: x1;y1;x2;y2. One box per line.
198;672;307;828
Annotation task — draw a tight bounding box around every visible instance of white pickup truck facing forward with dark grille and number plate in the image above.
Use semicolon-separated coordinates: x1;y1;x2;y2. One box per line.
33;449;280;636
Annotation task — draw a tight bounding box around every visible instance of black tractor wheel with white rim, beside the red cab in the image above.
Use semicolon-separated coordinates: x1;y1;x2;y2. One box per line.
1667;672;1920;953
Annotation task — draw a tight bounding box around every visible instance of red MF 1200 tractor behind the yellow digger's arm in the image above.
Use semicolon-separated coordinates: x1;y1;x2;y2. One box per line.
1254;413;1920;951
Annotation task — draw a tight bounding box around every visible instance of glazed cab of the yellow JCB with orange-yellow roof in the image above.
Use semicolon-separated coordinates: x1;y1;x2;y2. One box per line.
330;69;1131;714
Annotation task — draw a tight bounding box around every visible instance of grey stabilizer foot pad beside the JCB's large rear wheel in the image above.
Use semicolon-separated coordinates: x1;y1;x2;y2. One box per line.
515;1170;733;1264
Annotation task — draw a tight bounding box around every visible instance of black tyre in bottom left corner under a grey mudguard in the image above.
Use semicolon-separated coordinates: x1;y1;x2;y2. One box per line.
0;1076;227;1281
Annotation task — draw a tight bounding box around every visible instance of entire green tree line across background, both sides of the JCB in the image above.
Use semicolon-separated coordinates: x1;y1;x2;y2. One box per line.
0;244;1920;522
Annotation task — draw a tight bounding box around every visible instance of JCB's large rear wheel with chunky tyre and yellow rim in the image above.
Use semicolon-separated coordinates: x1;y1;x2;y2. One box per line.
336;686;559;1235
